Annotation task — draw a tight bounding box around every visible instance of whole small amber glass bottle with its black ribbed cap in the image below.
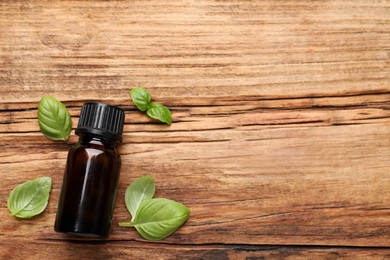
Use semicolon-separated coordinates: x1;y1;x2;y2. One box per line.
54;102;124;238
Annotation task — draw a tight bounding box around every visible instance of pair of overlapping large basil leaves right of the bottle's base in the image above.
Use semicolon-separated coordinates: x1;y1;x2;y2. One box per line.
119;176;190;240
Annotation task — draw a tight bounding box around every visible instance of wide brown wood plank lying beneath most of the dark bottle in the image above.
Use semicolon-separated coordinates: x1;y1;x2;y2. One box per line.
0;111;390;246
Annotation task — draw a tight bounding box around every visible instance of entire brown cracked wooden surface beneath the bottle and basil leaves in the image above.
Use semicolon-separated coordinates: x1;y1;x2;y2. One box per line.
0;0;390;259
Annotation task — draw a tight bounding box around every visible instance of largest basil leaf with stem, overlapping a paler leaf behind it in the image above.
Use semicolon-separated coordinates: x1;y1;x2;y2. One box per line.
119;198;190;240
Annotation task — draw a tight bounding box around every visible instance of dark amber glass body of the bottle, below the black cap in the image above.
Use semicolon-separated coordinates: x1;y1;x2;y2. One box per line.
55;134;121;237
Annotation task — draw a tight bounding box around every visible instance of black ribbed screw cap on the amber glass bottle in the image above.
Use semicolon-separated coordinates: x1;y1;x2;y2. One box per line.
75;102;125;142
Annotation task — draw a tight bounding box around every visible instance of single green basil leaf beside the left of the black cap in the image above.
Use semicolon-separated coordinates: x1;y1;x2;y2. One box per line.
38;96;72;141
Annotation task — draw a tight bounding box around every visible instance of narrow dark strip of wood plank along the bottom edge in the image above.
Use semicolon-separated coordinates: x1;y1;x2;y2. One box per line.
0;238;390;260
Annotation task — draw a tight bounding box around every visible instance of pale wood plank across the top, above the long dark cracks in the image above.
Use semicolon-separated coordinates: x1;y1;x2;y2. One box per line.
0;0;390;102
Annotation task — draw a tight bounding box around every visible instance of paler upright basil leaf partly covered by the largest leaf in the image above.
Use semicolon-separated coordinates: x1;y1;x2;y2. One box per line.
125;176;155;221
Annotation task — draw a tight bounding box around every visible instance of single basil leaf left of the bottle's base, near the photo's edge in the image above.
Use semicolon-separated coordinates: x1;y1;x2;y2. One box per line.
7;177;51;218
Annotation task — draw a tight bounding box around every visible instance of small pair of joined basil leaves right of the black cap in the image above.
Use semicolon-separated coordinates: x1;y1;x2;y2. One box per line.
130;88;172;125
